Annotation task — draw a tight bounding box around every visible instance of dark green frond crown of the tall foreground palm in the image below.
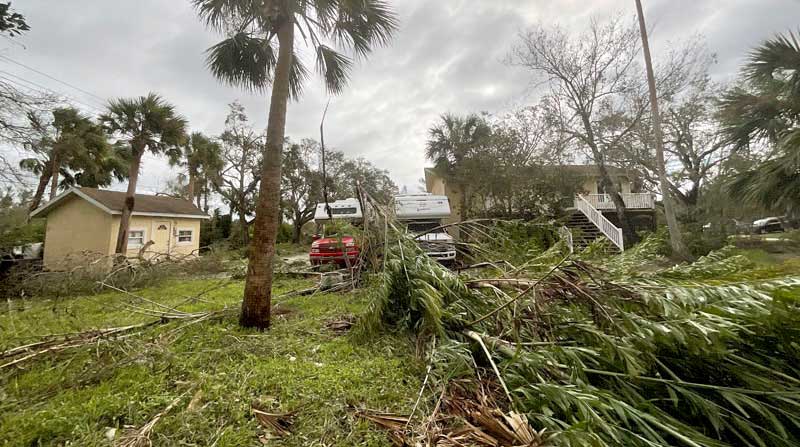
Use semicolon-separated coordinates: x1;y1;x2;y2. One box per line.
192;0;398;99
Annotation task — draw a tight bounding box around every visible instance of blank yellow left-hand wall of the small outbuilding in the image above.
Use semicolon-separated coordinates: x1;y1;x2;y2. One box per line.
43;197;111;270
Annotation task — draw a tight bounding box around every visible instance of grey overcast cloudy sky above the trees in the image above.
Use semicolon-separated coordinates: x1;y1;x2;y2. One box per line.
0;0;800;198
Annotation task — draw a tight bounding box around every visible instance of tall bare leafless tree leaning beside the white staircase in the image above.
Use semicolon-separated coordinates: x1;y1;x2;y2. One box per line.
508;16;694;245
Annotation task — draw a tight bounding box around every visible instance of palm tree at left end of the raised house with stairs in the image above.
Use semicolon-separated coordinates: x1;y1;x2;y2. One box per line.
425;113;492;220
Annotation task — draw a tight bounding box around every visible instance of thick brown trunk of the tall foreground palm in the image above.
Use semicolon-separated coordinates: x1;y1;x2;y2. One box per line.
239;18;294;329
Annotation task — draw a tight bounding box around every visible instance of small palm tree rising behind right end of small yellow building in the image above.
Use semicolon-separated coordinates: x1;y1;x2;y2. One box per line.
167;132;223;211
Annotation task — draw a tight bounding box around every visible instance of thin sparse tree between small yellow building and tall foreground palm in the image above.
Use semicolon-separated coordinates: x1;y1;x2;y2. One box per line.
212;102;264;246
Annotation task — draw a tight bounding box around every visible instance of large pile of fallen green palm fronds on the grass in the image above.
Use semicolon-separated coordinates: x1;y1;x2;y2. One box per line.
360;224;800;446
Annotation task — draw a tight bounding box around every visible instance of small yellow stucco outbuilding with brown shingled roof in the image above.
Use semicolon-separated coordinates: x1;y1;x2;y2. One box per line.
31;188;208;270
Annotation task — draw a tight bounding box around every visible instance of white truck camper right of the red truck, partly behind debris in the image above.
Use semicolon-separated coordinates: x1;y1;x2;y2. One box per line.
394;193;456;264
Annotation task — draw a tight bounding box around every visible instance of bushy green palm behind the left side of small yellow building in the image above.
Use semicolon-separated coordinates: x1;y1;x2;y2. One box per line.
20;107;126;211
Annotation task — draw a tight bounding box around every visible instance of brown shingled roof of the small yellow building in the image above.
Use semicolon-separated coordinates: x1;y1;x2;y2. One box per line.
31;188;208;219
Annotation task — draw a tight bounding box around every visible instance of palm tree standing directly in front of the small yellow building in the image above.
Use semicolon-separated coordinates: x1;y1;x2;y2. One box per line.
100;93;186;257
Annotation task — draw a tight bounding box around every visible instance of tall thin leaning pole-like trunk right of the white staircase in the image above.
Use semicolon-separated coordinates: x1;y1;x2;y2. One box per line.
635;0;691;260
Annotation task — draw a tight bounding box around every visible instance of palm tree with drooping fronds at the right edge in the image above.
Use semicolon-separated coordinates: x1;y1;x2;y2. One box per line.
720;32;800;214
